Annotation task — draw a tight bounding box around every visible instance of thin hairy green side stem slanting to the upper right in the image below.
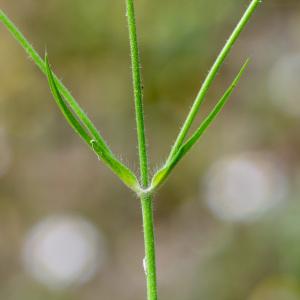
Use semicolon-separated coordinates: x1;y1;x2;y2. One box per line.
167;0;261;161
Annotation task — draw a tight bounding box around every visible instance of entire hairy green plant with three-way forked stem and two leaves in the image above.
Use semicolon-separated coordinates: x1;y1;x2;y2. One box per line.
0;0;261;300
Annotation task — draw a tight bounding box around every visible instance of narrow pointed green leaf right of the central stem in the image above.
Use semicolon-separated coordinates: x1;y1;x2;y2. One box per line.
151;59;249;190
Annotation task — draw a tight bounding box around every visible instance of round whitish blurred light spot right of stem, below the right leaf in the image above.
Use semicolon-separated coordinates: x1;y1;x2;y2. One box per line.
204;154;287;222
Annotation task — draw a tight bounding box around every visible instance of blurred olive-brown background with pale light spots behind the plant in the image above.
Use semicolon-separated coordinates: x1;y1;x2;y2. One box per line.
0;0;300;300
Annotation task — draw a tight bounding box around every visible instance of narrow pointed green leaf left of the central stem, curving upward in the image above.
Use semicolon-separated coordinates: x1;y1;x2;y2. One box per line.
45;55;139;192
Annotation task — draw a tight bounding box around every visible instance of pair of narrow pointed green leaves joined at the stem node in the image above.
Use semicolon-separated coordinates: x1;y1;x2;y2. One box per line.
45;54;249;194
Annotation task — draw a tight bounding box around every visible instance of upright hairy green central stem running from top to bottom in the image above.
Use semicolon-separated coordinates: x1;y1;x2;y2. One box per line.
126;0;157;300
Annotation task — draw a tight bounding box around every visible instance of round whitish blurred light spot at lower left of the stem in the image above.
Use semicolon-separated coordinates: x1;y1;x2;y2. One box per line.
22;215;105;289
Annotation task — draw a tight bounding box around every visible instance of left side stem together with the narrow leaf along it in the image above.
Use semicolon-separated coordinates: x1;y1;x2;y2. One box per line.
0;9;140;192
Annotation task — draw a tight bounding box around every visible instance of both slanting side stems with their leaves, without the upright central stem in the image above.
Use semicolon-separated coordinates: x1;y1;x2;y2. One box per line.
0;0;259;194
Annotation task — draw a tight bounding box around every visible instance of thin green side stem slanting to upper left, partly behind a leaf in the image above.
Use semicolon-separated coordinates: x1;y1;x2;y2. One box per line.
0;10;110;151
